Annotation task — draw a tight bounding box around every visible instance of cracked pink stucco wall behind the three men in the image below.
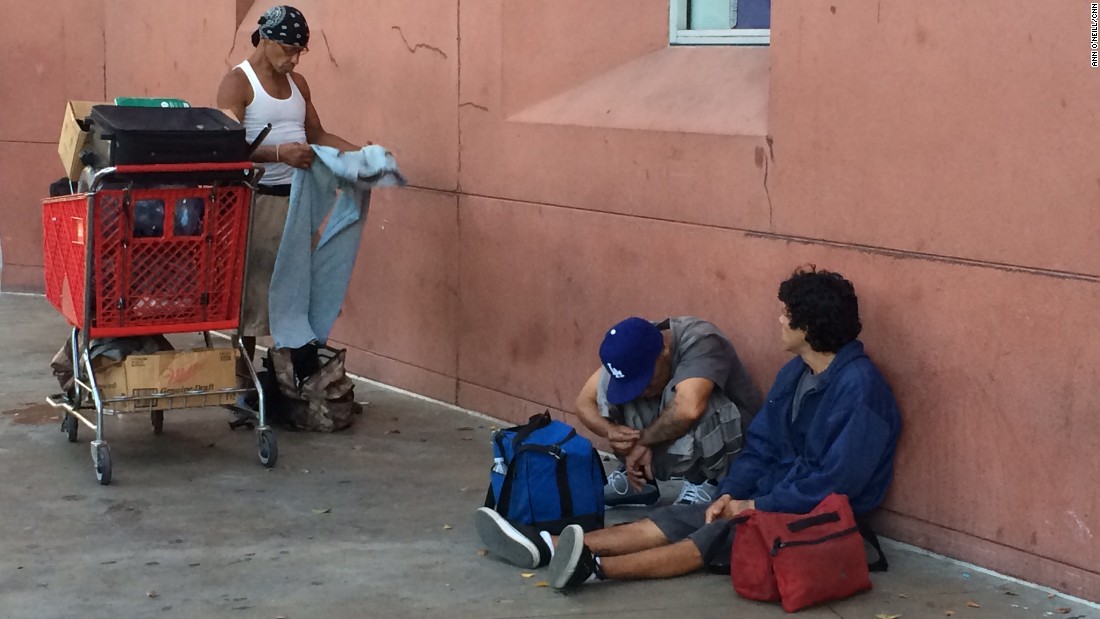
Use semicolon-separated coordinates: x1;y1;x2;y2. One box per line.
0;0;1100;599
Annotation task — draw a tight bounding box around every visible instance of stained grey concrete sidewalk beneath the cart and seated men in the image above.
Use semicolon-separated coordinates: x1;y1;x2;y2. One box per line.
0;295;1100;619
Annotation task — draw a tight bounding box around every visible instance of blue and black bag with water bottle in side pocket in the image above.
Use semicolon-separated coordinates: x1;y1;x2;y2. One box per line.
485;411;607;535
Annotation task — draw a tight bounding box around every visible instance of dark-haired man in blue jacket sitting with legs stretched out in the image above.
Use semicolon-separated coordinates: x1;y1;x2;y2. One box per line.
476;269;901;588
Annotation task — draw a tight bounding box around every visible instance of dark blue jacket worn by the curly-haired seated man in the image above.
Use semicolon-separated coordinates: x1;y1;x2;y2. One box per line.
718;341;901;513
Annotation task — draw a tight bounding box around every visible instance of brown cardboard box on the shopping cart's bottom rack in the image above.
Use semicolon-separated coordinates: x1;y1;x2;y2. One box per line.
96;349;237;411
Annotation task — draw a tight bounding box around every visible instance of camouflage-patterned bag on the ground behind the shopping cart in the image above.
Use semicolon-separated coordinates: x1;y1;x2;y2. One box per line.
264;349;363;432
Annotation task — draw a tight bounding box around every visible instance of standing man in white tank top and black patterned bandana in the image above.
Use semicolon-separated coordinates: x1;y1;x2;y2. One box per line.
211;5;360;409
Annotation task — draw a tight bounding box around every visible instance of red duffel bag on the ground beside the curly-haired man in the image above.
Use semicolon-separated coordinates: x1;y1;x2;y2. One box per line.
729;494;888;612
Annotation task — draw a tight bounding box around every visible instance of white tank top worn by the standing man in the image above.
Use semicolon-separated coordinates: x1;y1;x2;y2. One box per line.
237;59;306;185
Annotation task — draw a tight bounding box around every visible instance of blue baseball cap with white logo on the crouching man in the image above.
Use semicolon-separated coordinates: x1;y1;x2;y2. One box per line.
600;316;664;405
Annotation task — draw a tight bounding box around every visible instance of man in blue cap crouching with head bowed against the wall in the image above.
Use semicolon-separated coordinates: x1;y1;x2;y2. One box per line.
576;316;761;507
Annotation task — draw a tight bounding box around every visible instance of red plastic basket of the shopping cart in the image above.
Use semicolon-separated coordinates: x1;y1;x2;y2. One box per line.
42;185;252;338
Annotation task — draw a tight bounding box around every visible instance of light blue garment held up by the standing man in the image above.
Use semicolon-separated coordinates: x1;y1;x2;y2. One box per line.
267;145;406;349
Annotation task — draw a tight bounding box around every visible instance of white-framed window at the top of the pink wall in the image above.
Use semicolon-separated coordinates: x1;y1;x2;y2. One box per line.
669;0;771;45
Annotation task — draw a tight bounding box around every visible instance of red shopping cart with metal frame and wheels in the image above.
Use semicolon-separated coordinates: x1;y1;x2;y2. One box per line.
42;162;278;485
